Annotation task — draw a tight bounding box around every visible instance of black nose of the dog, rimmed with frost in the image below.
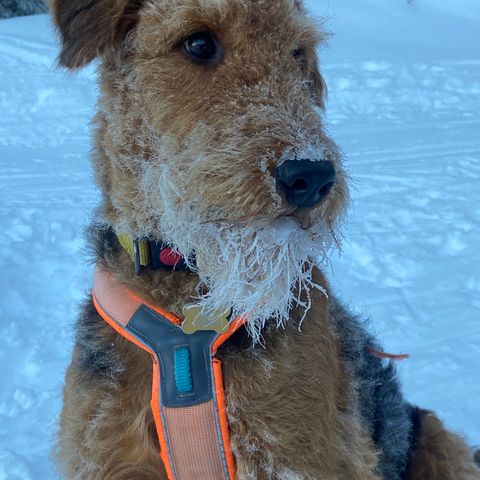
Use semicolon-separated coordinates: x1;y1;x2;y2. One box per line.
275;160;336;208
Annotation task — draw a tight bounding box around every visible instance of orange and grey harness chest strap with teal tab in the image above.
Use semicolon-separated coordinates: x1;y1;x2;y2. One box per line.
92;267;244;480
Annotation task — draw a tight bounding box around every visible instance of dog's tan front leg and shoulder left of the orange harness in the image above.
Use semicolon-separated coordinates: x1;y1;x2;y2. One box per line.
55;306;167;480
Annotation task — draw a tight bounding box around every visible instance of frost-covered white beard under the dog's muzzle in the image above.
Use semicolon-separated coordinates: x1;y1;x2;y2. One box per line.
149;182;332;344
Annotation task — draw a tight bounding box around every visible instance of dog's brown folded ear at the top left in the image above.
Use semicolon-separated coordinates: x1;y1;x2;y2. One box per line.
51;0;143;68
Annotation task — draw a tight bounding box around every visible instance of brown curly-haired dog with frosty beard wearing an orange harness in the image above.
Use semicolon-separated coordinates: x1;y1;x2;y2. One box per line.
52;0;480;480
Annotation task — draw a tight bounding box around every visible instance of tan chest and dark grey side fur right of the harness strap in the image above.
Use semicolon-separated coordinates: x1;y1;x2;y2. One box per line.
219;304;414;480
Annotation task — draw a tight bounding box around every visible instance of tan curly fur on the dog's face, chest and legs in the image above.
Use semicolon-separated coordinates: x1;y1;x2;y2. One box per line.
52;0;480;480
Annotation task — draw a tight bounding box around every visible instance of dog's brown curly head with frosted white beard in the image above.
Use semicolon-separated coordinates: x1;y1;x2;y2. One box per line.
53;0;347;340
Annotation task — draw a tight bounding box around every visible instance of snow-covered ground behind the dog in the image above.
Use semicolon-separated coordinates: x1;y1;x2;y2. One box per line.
0;0;480;480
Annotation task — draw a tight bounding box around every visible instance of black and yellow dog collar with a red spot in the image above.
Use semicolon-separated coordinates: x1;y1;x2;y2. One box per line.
117;234;195;275
